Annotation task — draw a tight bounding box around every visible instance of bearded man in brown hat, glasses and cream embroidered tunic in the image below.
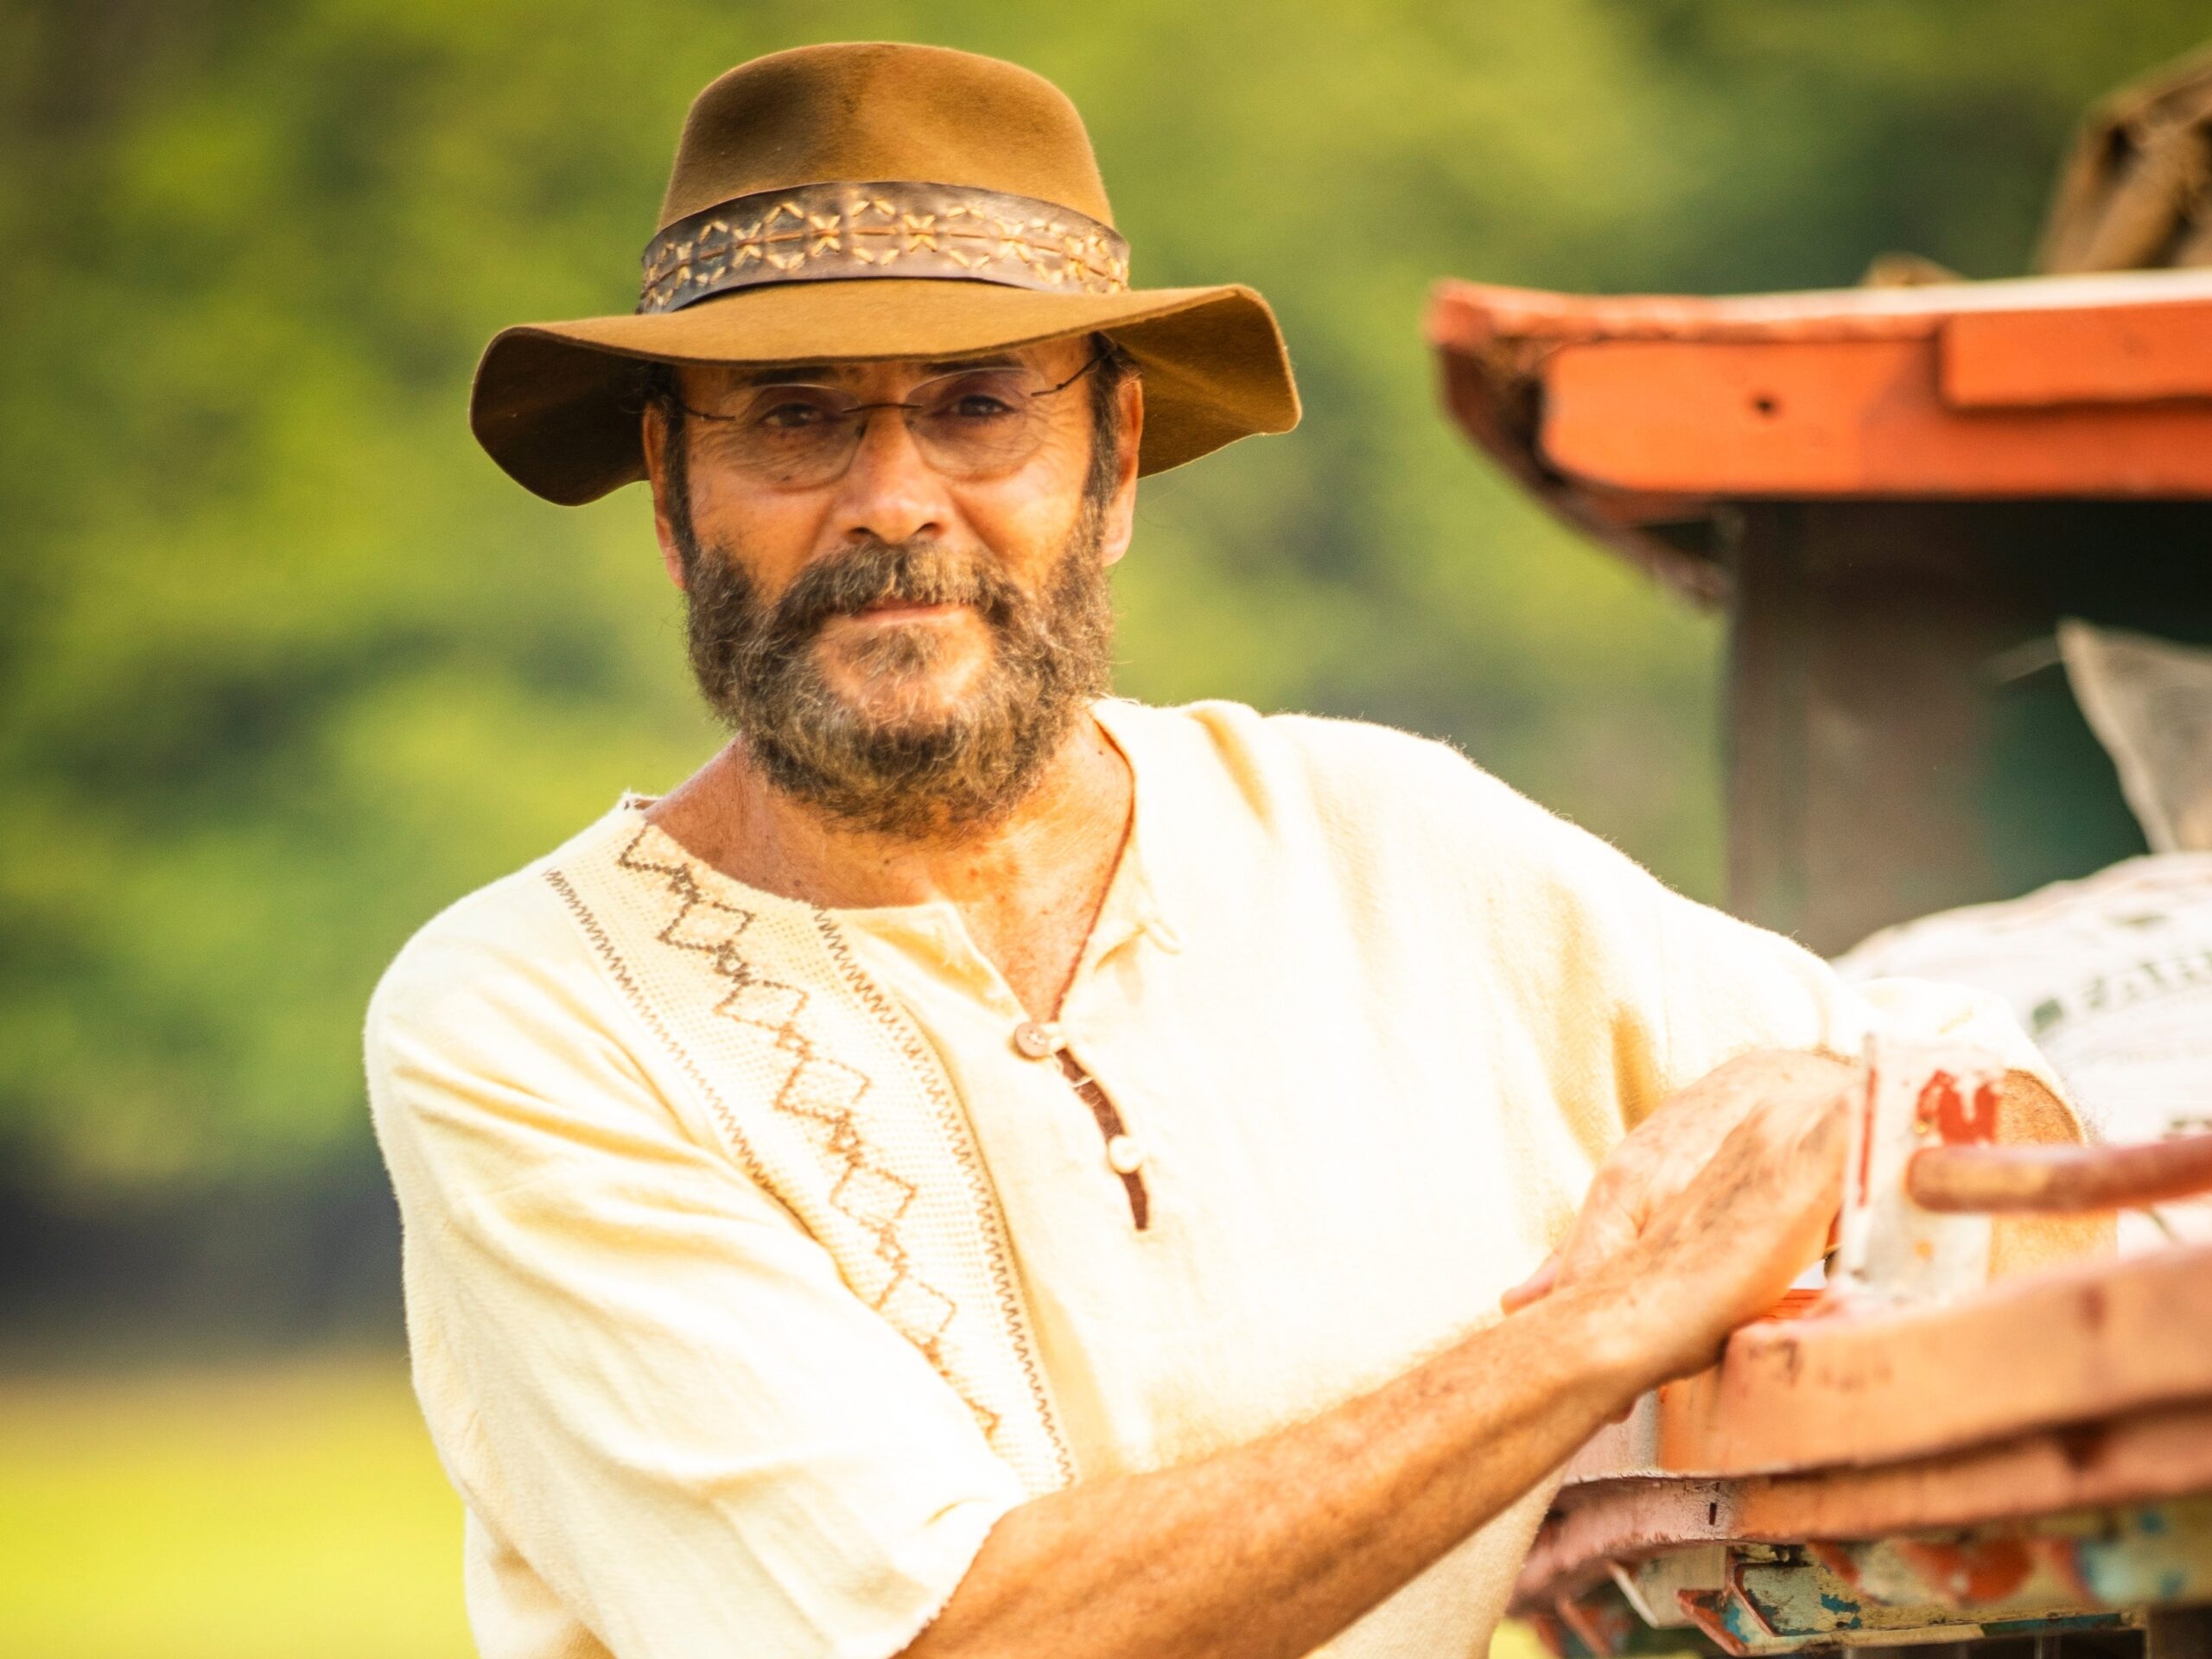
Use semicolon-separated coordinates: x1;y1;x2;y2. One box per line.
367;44;2079;1659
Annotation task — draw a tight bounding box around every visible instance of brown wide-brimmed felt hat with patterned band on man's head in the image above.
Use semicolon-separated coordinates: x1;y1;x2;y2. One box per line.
469;44;1299;506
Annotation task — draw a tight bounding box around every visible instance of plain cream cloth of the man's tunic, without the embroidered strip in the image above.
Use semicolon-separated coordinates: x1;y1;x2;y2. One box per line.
367;703;2037;1659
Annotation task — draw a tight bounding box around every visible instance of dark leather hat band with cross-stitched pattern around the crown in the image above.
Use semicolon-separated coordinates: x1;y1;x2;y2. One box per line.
637;181;1128;312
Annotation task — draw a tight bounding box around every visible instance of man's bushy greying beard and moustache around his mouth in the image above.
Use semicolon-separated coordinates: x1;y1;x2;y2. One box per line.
679;519;1113;838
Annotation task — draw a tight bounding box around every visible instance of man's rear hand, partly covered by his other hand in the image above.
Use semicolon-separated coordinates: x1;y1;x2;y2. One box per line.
1504;1048;1853;1314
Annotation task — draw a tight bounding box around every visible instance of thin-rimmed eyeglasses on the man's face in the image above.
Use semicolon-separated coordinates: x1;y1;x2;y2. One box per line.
679;352;1106;489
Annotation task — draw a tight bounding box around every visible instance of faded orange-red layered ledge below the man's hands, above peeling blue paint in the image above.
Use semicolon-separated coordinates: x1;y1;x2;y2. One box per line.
1522;1248;2212;1606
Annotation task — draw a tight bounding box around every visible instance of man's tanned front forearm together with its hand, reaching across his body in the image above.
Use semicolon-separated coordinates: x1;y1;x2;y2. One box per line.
909;1052;1852;1659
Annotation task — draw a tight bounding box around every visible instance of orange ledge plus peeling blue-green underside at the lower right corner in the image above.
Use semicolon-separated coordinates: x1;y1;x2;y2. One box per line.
1516;1248;2212;1659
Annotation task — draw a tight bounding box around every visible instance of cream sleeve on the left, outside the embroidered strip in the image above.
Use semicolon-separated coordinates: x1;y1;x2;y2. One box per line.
367;889;1024;1659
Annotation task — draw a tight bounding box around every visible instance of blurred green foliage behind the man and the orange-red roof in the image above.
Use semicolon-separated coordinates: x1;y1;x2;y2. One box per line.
0;0;2205;1190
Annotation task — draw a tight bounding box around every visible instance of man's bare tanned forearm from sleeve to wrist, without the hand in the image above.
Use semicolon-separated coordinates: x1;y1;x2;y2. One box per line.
907;1292;1656;1659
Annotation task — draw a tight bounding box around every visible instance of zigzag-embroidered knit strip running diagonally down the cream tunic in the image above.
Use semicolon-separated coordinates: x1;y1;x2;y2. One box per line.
540;818;1075;1493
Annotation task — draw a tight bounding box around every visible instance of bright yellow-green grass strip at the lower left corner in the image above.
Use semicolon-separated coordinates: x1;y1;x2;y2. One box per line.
0;1356;474;1659
